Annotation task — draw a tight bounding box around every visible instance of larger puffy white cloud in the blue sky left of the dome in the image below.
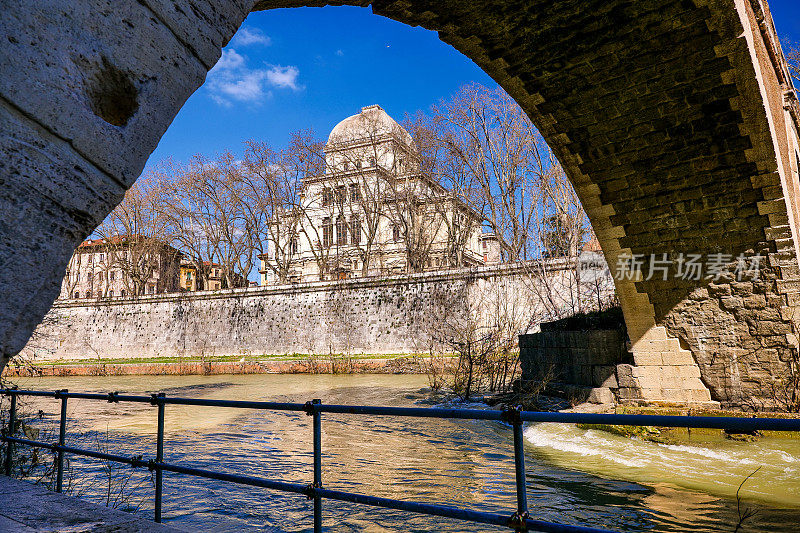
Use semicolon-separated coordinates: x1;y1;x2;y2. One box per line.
206;48;302;107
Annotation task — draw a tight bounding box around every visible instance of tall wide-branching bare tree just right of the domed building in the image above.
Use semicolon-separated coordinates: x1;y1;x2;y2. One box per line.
432;84;552;261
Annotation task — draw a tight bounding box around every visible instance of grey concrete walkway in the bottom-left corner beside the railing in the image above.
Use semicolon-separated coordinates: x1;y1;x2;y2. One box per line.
0;476;180;533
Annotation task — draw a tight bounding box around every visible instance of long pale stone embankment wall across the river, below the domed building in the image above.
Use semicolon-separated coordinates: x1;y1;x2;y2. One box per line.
23;266;600;359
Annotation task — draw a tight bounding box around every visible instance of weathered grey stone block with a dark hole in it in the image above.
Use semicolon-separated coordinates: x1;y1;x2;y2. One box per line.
0;0;209;186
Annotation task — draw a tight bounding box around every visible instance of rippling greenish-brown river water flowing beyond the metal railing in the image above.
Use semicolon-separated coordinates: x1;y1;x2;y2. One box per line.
9;375;800;532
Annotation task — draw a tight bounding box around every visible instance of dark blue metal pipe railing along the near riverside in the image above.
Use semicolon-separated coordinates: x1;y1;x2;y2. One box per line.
0;389;800;533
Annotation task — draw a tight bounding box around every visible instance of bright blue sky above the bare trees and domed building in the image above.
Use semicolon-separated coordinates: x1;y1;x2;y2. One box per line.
148;0;800;165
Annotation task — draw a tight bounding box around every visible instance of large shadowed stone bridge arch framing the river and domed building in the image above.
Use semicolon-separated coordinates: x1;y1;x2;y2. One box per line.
0;0;800;408
